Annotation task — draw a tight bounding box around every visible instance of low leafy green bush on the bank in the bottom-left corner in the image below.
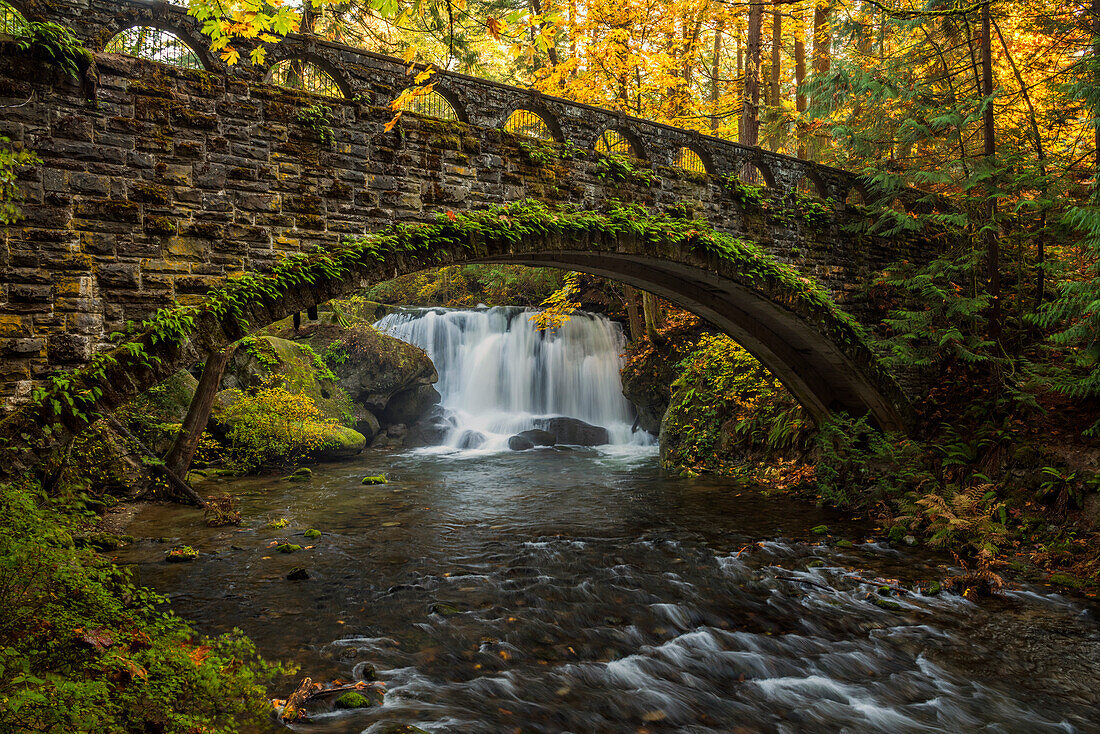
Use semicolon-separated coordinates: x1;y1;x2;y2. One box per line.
0;485;288;734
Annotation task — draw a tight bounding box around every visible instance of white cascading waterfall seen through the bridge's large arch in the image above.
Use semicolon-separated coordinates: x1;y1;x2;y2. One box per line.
375;307;653;450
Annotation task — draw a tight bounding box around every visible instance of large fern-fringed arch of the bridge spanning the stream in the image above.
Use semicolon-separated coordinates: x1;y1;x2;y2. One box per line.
0;204;910;475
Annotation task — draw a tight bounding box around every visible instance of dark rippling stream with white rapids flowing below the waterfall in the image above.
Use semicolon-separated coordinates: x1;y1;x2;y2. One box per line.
116;448;1100;733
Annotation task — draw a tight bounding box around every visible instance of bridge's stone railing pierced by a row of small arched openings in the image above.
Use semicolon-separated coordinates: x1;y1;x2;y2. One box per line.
11;0;869;206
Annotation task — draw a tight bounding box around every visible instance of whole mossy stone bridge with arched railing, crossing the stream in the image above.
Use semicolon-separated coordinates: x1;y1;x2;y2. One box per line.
0;0;921;464
